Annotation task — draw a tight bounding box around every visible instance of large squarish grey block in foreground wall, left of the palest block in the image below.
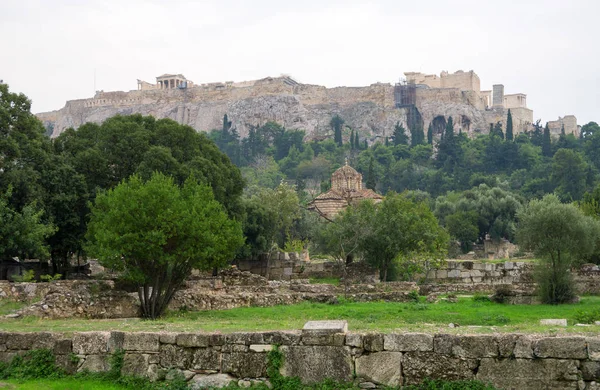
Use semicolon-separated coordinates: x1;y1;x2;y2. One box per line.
280;346;353;384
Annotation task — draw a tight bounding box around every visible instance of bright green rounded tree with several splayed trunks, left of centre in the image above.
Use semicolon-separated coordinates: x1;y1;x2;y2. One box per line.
87;173;243;319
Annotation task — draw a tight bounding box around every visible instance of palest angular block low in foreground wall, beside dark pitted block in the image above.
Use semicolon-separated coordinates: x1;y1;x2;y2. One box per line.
356;352;402;387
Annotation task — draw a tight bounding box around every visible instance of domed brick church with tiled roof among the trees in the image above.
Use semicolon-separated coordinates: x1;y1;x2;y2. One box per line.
308;162;383;219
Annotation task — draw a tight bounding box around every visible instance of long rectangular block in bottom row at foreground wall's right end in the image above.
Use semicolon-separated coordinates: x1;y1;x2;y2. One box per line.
477;359;579;390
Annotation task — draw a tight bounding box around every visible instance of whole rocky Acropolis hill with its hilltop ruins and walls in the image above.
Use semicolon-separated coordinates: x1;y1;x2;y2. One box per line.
37;70;579;141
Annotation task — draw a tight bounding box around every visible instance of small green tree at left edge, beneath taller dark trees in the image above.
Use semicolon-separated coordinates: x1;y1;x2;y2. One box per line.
0;188;56;260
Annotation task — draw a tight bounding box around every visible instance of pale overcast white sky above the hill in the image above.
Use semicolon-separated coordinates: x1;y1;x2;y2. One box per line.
0;0;600;125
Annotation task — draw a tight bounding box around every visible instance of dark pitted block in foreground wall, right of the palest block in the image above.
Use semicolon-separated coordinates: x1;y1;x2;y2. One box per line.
402;352;478;385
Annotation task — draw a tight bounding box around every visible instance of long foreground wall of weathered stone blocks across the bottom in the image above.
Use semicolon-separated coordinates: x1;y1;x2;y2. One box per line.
0;329;600;390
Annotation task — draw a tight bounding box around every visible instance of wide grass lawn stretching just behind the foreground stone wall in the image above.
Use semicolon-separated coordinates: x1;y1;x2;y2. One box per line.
0;296;600;334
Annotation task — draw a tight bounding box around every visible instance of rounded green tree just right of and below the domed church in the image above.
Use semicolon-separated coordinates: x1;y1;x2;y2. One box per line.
360;193;448;281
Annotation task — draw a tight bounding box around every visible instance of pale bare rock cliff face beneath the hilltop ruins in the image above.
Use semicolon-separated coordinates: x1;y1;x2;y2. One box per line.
38;77;489;141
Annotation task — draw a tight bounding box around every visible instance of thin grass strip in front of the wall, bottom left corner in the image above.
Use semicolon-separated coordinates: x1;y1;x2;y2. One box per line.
0;378;126;390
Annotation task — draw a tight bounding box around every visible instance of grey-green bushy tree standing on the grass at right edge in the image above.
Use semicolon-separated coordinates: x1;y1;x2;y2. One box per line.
517;195;600;304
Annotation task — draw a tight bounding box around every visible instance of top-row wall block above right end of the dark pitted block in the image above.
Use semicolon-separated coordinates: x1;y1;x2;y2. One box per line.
433;334;498;358
